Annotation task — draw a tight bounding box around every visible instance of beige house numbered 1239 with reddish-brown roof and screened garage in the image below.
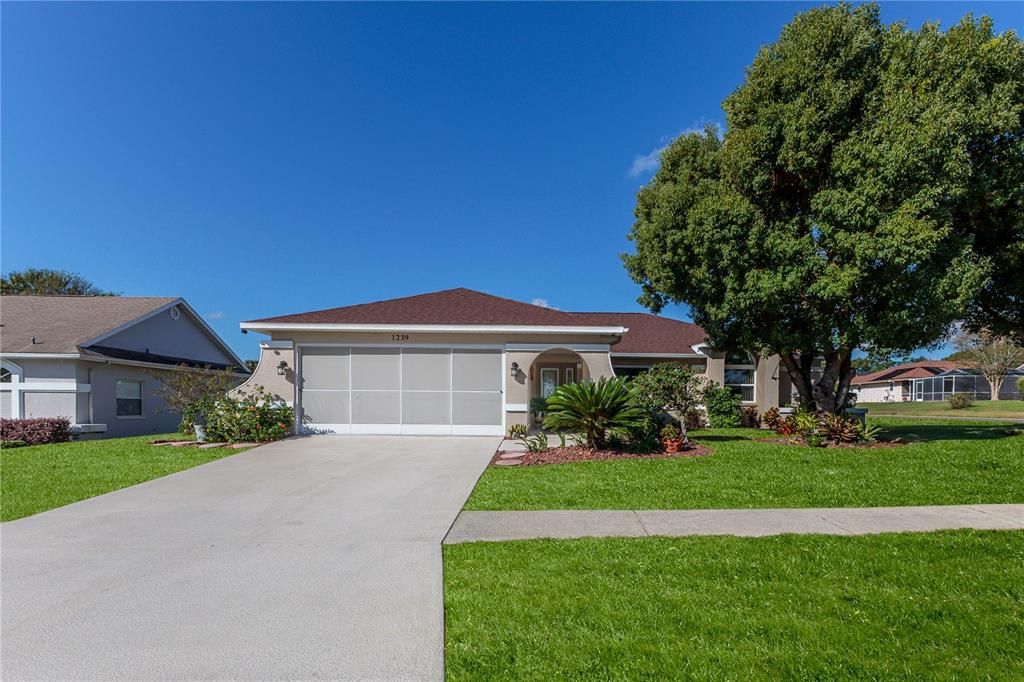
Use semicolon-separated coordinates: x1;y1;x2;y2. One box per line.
240;289;790;435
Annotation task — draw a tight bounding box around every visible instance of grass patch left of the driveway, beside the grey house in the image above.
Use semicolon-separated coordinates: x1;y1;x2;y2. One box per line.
0;434;243;521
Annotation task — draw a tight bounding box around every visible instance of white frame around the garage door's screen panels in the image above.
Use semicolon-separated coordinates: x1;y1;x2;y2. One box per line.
294;342;508;435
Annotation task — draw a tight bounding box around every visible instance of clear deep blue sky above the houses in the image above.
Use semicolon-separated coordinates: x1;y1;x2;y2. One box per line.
0;2;1024;357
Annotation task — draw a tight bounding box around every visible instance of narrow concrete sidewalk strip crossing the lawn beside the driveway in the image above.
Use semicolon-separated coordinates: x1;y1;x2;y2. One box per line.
444;505;1024;545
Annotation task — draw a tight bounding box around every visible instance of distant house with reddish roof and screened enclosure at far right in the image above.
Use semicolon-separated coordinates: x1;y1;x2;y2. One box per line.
851;360;1024;402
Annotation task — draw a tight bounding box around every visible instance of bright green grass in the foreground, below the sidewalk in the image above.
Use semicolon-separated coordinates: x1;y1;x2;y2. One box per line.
444;531;1024;680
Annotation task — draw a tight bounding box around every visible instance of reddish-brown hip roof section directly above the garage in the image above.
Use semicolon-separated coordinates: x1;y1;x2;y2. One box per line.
251;289;622;327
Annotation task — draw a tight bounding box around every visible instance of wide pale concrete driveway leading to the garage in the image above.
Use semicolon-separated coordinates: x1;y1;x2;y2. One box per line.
2;436;499;680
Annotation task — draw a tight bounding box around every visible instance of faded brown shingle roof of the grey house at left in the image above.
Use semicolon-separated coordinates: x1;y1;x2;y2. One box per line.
0;296;177;353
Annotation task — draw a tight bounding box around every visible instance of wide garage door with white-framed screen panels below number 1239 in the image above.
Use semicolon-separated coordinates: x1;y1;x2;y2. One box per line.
299;346;504;435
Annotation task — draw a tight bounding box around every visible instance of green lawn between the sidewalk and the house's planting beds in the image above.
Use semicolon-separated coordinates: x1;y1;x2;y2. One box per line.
466;419;1024;510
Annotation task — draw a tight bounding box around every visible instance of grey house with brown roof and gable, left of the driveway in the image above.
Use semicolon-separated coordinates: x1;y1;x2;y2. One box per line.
0;296;249;436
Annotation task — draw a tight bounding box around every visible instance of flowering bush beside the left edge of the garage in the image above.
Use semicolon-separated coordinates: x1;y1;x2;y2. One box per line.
206;386;295;442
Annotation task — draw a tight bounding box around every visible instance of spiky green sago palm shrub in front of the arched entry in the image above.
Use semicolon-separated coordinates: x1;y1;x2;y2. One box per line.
544;377;645;450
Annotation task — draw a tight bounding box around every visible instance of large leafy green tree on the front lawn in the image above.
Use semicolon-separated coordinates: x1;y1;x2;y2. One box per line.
624;4;1024;412
